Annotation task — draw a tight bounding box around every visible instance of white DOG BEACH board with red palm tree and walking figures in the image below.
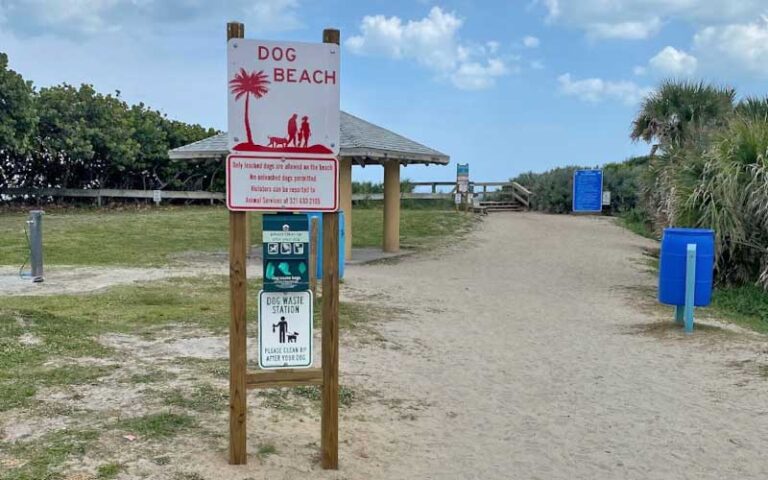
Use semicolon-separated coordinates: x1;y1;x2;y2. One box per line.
227;38;340;155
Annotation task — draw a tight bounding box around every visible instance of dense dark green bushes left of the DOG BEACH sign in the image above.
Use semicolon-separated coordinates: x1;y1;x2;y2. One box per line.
0;52;218;195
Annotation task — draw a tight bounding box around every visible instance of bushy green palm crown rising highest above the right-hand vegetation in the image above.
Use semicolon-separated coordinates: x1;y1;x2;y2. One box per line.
630;80;735;156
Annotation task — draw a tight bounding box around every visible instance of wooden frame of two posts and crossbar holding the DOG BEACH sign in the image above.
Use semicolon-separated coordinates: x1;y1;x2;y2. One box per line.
227;22;340;469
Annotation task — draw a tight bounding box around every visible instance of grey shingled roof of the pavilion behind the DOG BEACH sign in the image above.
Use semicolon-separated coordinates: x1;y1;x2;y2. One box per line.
168;112;449;165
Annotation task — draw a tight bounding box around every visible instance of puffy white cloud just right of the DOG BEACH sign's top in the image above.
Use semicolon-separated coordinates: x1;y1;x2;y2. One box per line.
344;7;511;90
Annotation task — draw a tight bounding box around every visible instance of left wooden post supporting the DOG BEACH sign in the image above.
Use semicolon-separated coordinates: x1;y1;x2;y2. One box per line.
227;22;248;465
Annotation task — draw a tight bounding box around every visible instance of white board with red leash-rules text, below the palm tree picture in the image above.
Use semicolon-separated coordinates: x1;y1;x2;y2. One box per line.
227;153;339;212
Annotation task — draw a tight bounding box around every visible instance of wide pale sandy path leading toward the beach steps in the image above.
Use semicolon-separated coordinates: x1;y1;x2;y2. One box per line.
316;214;768;480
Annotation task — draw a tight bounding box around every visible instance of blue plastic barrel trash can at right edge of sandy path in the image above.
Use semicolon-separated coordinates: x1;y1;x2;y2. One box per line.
659;228;715;307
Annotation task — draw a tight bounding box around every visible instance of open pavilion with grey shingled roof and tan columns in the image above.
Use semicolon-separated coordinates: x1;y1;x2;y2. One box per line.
168;111;449;259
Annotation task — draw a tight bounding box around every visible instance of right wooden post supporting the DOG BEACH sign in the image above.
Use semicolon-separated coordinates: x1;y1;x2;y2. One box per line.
320;29;341;470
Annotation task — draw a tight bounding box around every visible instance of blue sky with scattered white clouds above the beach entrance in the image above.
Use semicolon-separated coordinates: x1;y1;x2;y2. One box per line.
0;0;768;182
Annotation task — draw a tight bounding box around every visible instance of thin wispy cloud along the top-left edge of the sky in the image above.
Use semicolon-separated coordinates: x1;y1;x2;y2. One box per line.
0;0;301;37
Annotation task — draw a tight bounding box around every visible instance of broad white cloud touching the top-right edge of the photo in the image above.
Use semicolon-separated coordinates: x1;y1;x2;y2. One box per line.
534;0;768;39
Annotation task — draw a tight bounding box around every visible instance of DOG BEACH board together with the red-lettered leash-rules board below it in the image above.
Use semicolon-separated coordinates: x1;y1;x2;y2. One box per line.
226;38;340;212
